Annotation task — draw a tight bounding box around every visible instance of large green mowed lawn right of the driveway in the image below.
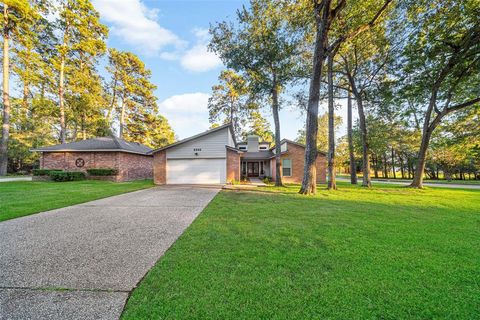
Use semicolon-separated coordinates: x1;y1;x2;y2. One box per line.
123;183;480;319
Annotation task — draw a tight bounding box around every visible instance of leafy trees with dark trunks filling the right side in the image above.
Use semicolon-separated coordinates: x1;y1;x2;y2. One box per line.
204;0;480;189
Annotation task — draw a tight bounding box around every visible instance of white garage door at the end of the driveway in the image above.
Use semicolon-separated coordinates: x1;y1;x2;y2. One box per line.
167;159;227;184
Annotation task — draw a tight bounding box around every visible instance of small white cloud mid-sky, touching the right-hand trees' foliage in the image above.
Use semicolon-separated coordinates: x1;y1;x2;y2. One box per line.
180;28;222;72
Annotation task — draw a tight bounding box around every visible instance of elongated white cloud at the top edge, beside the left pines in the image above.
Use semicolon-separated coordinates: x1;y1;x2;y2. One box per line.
93;0;185;54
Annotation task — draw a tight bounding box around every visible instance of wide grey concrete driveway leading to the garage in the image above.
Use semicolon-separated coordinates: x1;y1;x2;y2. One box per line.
0;186;219;319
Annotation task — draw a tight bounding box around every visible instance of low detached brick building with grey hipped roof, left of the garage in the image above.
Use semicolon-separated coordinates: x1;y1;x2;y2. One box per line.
32;136;153;182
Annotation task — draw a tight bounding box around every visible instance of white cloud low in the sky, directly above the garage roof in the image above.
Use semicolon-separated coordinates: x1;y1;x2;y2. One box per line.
159;92;210;139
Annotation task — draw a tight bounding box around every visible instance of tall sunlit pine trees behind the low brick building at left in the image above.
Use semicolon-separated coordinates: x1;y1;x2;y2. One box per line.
0;0;174;175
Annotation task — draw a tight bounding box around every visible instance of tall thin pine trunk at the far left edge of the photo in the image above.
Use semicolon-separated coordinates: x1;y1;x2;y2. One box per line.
0;4;10;176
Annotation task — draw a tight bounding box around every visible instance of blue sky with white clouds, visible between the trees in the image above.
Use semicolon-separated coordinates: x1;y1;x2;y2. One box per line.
93;0;352;139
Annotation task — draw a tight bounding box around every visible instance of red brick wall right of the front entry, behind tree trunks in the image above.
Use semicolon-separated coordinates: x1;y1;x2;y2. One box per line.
270;143;327;183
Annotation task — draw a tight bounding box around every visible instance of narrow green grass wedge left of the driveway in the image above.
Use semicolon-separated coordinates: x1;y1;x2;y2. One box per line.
0;180;153;221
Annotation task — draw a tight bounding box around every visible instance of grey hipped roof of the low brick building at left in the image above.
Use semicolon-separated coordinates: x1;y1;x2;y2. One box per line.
31;136;152;155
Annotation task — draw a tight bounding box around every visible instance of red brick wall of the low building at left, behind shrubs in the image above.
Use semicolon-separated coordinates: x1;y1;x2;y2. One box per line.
40;152;153;182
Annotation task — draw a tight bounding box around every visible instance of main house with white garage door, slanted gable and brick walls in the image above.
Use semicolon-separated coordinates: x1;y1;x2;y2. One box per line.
151;125;326;184
